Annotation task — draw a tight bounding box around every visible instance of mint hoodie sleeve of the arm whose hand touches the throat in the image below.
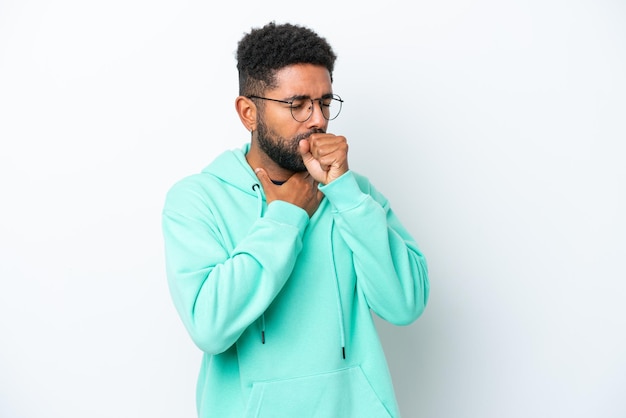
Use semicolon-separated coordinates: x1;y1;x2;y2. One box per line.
162;181;309;354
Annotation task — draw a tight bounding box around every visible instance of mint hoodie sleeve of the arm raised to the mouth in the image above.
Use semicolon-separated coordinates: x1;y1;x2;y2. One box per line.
319;171;430;325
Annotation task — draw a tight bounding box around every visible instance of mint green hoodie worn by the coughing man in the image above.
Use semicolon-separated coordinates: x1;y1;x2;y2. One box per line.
163;144;429;418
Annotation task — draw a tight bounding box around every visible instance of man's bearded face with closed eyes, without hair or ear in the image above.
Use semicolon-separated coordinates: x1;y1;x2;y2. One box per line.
257;64;332;172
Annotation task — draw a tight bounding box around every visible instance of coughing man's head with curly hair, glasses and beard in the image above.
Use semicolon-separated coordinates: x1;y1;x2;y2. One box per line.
236;22;341;173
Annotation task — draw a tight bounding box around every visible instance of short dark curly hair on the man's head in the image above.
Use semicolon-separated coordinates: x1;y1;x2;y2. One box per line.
237;22;337;96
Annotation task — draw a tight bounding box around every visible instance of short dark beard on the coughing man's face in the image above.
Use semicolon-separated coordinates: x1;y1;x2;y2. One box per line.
257;118;324;173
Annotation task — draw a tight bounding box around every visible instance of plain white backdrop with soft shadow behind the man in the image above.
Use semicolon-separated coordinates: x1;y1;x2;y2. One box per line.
0;0;626;418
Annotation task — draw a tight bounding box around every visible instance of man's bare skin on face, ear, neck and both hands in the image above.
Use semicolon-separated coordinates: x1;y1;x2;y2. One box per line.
235;64;348;216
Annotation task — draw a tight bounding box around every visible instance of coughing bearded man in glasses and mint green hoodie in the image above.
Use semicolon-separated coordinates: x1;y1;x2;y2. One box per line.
163;22;429;418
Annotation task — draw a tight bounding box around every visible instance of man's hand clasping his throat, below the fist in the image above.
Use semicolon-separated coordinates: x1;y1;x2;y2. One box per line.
254;168;324;218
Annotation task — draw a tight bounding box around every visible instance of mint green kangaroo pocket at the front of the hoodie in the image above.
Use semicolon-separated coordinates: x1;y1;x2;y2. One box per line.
245;367;390;418
